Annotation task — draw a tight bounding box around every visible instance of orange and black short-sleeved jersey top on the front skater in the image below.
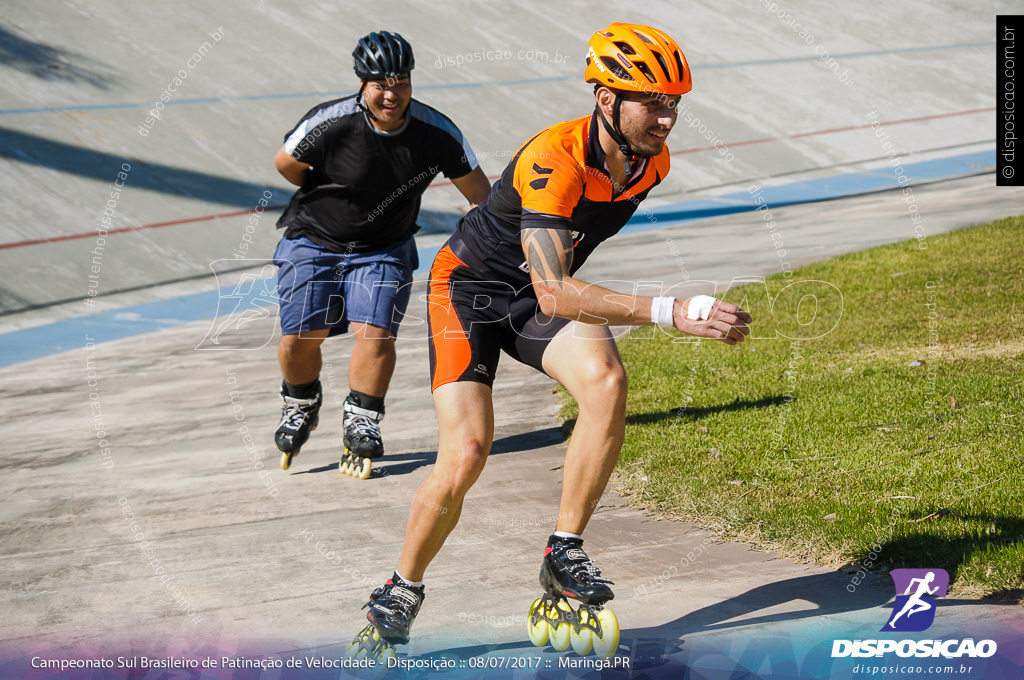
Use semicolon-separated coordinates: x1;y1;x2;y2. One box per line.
449;111;670;288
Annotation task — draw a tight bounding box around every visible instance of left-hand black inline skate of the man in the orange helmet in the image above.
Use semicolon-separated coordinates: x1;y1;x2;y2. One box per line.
346;573;424;665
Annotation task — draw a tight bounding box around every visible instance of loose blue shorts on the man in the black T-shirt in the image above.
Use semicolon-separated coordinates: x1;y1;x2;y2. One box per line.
273;237;419;335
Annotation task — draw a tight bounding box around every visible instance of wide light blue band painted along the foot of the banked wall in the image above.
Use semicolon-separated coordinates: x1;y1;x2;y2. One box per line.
0;148;996;367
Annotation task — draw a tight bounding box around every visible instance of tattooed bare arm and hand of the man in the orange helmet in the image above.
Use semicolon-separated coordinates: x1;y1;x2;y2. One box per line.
522;228;751;345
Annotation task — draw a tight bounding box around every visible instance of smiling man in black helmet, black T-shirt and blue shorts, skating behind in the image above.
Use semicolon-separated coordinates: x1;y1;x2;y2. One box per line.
274;31;490;478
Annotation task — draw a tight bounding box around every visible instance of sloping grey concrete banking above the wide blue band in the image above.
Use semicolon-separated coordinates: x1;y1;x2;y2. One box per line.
0;0;1012;314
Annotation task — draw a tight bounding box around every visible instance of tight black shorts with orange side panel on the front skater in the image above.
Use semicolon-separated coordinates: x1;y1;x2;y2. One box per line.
427;245;569;390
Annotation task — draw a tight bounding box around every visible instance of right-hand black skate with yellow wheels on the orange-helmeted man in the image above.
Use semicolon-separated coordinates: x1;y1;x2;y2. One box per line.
527;536;620;658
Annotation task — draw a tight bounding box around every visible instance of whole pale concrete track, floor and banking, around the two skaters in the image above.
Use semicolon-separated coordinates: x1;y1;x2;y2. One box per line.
0;0;1024;678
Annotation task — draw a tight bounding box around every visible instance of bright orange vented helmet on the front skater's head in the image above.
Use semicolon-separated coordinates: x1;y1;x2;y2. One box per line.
584;24;693;95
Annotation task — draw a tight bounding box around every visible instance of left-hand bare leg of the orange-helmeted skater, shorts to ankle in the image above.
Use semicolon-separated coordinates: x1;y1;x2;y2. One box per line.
398;382;495;581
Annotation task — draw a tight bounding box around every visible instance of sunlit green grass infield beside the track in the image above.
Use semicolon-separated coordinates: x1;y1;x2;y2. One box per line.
563;217;1024;599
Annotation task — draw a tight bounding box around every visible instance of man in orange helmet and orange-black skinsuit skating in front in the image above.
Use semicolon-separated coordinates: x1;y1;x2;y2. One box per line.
349;24;751;658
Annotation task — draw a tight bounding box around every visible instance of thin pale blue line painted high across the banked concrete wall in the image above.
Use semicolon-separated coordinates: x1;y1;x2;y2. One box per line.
0;41;995;116
